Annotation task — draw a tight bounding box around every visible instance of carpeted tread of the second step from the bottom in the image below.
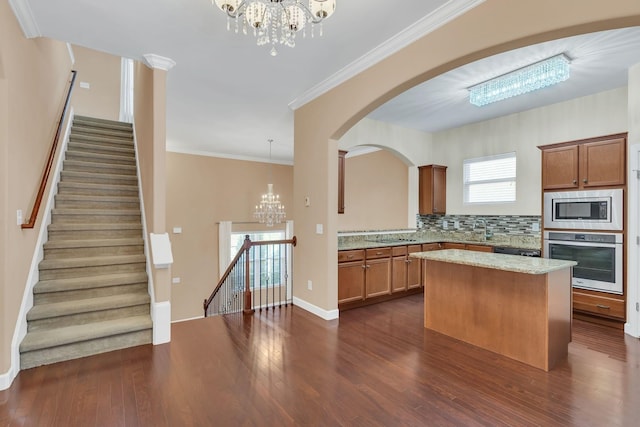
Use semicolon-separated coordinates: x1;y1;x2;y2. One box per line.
27;292;150;321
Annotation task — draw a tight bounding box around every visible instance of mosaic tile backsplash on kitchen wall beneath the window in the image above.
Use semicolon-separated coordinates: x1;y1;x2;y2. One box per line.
417;215;540;236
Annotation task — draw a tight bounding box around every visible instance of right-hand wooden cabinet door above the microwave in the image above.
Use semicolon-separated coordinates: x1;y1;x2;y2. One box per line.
580;138;626;188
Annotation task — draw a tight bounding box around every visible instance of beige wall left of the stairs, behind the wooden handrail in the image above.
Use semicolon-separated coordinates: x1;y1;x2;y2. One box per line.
0;2;71;375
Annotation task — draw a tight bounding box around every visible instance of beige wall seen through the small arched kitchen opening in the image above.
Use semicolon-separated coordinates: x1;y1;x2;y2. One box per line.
338;150;408;231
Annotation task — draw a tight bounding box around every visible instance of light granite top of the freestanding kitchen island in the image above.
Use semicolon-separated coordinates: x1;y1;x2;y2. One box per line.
410;249;578;274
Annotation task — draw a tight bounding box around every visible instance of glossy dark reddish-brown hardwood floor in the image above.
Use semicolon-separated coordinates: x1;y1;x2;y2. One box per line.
0;295;640;426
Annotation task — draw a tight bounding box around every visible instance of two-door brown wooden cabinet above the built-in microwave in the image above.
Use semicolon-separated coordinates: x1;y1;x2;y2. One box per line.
539;134;627;190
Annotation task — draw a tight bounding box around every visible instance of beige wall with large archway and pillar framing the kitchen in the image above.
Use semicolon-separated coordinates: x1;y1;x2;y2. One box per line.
293;0;640;317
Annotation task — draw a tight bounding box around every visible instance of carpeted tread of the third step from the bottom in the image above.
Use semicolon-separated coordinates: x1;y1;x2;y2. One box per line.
33;271;148;294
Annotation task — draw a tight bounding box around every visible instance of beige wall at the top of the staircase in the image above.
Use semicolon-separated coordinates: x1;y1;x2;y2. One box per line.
73;46;120;120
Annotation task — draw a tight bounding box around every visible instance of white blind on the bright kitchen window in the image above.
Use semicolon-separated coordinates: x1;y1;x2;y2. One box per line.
463;152;516;204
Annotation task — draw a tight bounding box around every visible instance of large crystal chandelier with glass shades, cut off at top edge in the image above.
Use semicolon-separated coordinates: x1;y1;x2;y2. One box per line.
211;0;337;56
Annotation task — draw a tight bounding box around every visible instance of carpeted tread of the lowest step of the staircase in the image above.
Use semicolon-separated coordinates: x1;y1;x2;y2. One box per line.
20;316;153;353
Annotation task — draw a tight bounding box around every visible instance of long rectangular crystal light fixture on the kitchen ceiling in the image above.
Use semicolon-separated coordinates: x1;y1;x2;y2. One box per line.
469;54;570;107
